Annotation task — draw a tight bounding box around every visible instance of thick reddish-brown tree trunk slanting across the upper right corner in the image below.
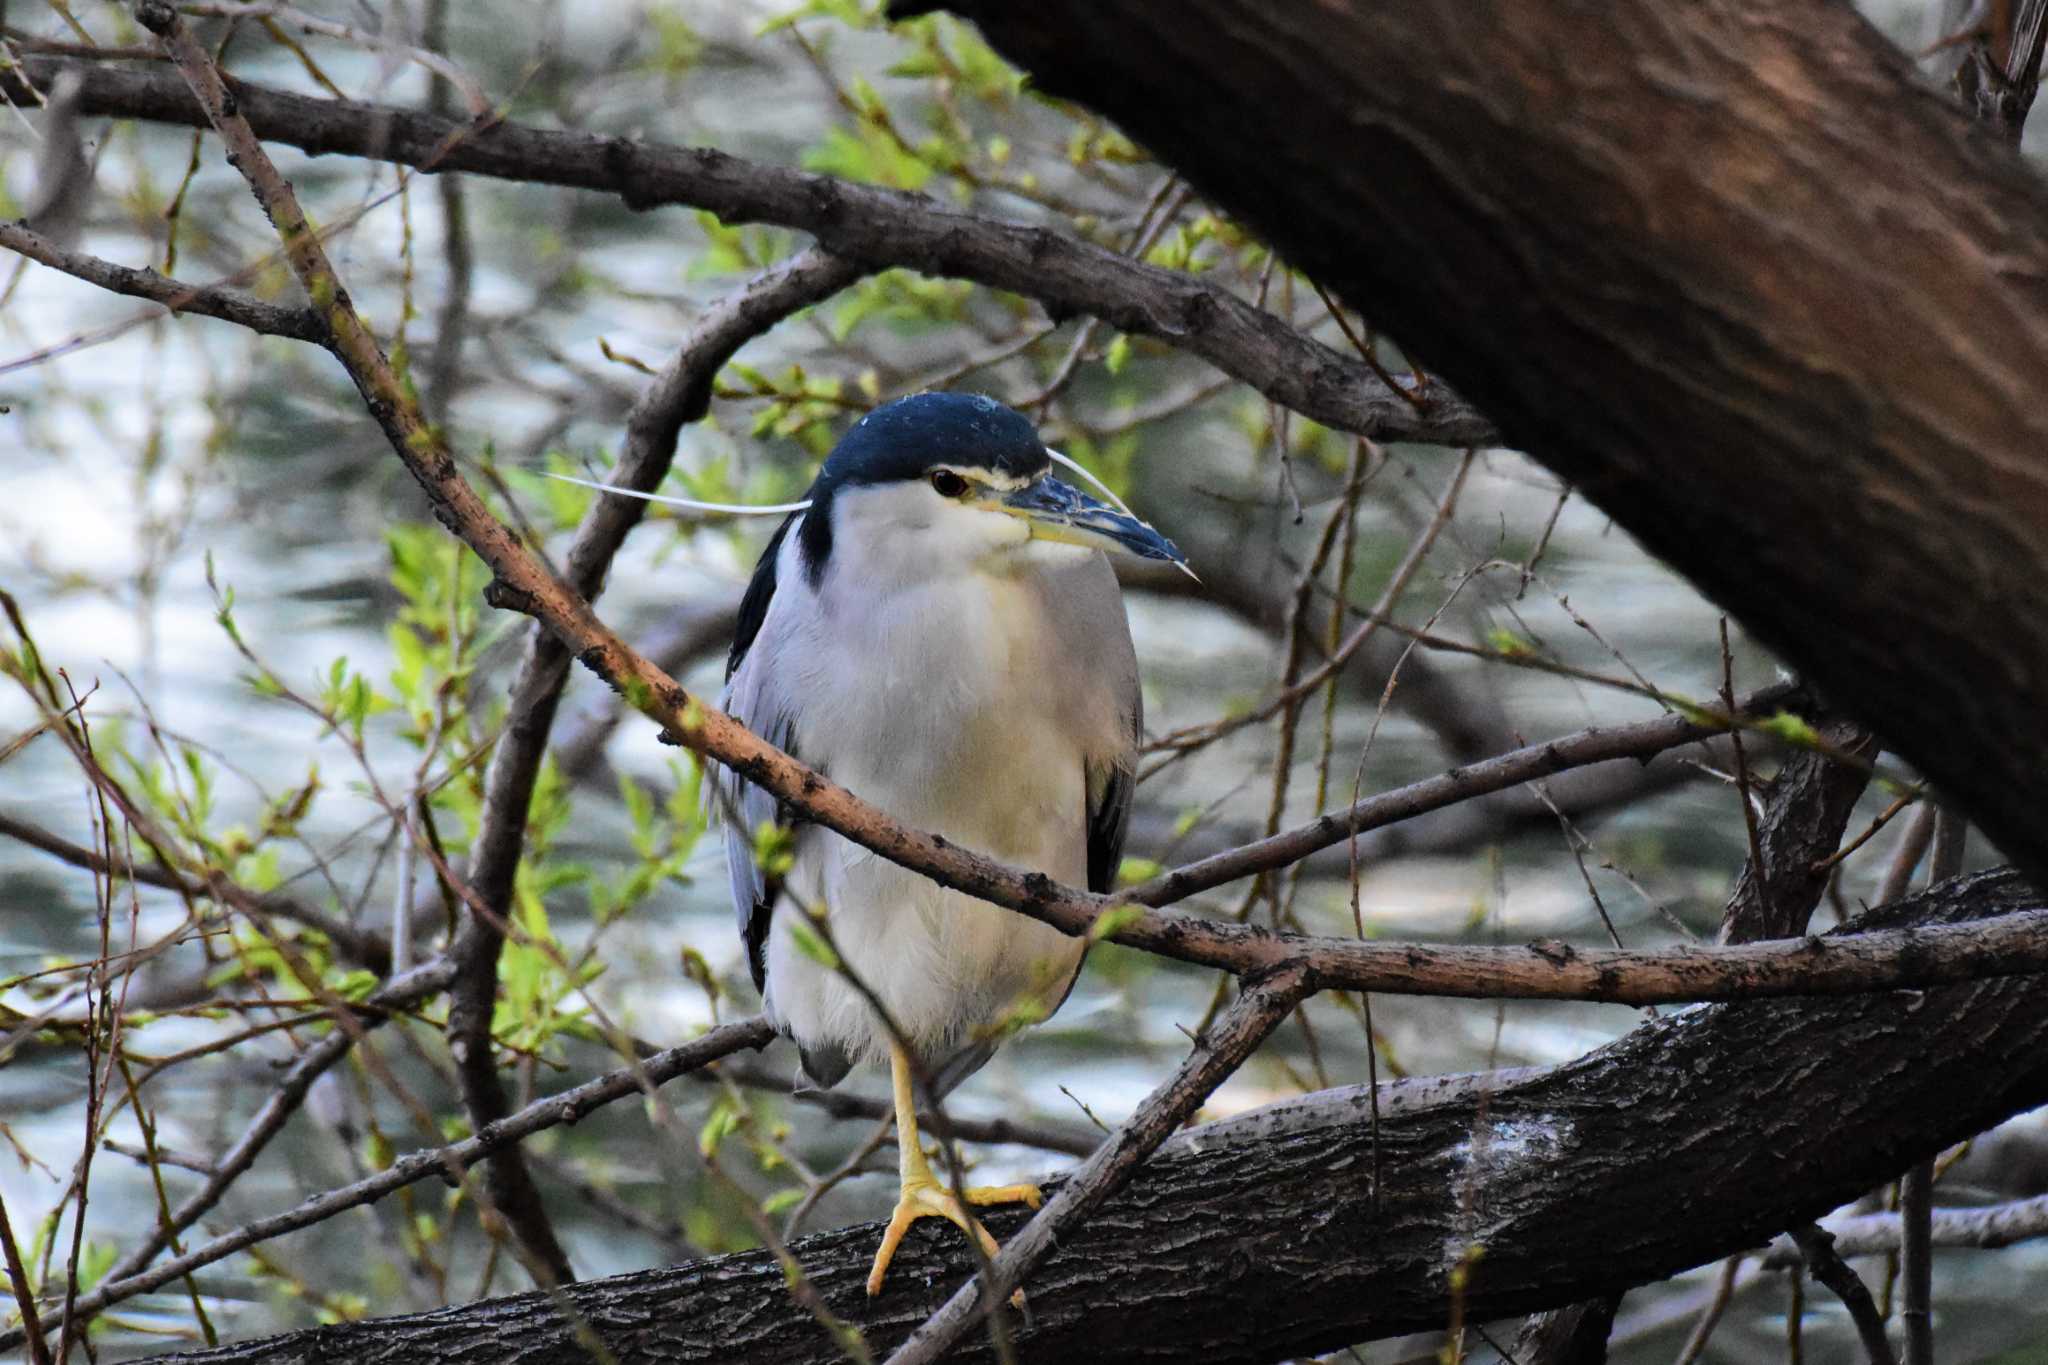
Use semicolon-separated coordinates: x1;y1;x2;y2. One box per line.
918;0;2048;872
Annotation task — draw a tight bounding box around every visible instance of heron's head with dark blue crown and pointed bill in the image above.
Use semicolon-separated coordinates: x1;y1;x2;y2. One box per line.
803;393;1188;577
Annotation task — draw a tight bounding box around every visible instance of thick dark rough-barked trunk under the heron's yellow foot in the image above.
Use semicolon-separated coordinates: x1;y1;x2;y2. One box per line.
151;874;2048;1365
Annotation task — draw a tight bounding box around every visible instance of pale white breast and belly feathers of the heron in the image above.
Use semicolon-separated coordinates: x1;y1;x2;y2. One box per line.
750;501;1135;1064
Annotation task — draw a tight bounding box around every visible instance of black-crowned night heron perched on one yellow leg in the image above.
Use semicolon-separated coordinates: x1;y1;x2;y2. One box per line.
721;393;1186;1293
